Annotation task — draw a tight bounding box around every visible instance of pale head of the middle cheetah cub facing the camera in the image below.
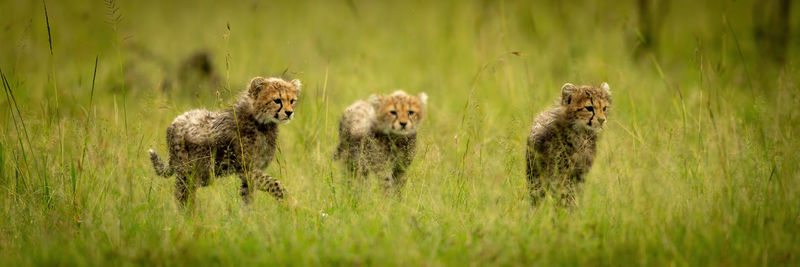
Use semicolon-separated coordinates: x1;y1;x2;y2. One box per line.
369;91;428;135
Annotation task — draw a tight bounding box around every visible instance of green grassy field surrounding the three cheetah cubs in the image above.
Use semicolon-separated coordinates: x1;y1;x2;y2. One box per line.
0;0;800;266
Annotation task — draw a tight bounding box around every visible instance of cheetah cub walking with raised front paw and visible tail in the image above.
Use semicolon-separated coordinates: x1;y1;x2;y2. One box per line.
150;77;300;205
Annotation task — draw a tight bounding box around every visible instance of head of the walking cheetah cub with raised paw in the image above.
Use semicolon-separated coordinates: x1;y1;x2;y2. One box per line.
247;77;301;124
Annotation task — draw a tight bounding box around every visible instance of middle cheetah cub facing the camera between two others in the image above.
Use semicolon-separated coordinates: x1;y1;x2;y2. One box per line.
334;91;428;193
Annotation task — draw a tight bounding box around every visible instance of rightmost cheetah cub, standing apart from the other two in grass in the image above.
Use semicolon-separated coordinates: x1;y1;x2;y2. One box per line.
526;83;611;205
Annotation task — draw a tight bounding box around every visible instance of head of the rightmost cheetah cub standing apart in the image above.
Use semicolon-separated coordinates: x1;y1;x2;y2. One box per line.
561;83;611;131
